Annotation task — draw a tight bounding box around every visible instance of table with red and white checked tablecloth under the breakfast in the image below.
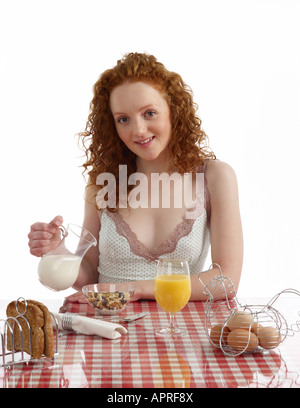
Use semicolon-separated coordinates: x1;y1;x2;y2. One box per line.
0;299;300;389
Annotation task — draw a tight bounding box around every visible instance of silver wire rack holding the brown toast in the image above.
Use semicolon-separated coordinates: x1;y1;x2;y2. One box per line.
0;297;59;368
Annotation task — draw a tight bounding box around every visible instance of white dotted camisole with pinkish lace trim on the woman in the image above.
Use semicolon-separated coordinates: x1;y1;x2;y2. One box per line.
98;166;210;283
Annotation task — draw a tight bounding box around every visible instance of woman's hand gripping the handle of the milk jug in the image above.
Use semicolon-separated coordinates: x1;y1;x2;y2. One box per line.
28;215;63;256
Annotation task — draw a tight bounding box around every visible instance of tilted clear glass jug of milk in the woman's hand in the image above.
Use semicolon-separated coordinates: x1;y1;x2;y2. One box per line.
38;224;97;291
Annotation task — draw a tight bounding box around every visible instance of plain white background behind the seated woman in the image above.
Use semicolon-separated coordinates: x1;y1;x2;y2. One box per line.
0;0;300;300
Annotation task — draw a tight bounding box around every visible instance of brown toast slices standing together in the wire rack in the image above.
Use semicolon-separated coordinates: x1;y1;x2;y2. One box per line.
6;300;54;359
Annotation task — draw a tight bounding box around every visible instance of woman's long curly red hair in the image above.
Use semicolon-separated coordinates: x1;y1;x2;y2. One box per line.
79;53;216;207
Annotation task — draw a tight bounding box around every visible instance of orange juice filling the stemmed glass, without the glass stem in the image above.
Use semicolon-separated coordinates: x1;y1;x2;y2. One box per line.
154;274;191;313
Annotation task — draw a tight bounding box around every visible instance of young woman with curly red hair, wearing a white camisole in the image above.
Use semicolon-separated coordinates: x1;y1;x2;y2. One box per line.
28;53;243;301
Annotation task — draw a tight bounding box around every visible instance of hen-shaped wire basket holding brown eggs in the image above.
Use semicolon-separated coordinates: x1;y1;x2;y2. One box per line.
198;263;300;356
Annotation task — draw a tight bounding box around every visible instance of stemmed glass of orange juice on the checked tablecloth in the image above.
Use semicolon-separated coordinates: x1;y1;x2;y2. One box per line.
154;258;191;337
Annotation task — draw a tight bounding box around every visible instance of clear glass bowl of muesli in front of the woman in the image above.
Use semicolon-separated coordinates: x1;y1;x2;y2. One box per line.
82;282;135;315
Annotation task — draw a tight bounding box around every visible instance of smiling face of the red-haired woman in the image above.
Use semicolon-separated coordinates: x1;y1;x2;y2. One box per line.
110;82;171;170
